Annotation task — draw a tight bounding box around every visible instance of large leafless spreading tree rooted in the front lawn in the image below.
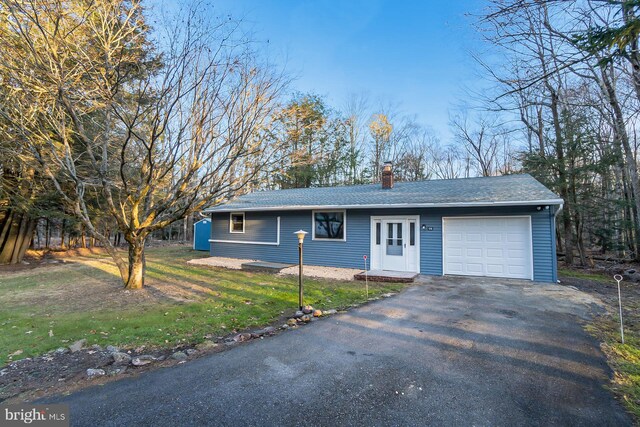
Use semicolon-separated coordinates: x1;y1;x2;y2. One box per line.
0;0;282;289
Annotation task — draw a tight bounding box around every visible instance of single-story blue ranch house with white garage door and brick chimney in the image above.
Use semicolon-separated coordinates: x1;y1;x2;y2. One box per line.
205;165;563;282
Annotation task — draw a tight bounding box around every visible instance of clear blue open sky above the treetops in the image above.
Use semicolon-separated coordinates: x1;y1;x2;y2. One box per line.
214;0;482;142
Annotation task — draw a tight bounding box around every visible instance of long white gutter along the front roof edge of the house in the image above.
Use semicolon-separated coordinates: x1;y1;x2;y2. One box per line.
203;199;564;213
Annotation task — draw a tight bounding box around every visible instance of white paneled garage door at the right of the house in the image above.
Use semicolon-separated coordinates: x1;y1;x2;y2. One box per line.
442;217;533;279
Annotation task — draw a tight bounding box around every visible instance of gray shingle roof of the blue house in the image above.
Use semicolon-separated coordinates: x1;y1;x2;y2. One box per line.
205;174;562;212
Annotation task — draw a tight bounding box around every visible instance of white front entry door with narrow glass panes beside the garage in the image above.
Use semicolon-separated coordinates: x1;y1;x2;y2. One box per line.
371;216;420;273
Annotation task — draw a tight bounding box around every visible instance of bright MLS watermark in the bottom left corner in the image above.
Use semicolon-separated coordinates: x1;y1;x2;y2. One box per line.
0;404;69;427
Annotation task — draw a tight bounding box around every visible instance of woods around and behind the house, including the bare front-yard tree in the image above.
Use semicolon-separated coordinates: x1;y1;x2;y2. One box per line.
0;0;640;288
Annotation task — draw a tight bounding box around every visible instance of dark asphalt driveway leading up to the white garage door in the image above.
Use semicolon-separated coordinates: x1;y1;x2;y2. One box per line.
43;278;631;426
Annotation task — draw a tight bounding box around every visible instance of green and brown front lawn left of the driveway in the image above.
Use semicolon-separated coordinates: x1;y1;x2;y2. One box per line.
0;247;404;366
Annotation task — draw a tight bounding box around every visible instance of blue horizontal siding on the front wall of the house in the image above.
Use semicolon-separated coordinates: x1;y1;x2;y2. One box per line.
211;206;557;282
